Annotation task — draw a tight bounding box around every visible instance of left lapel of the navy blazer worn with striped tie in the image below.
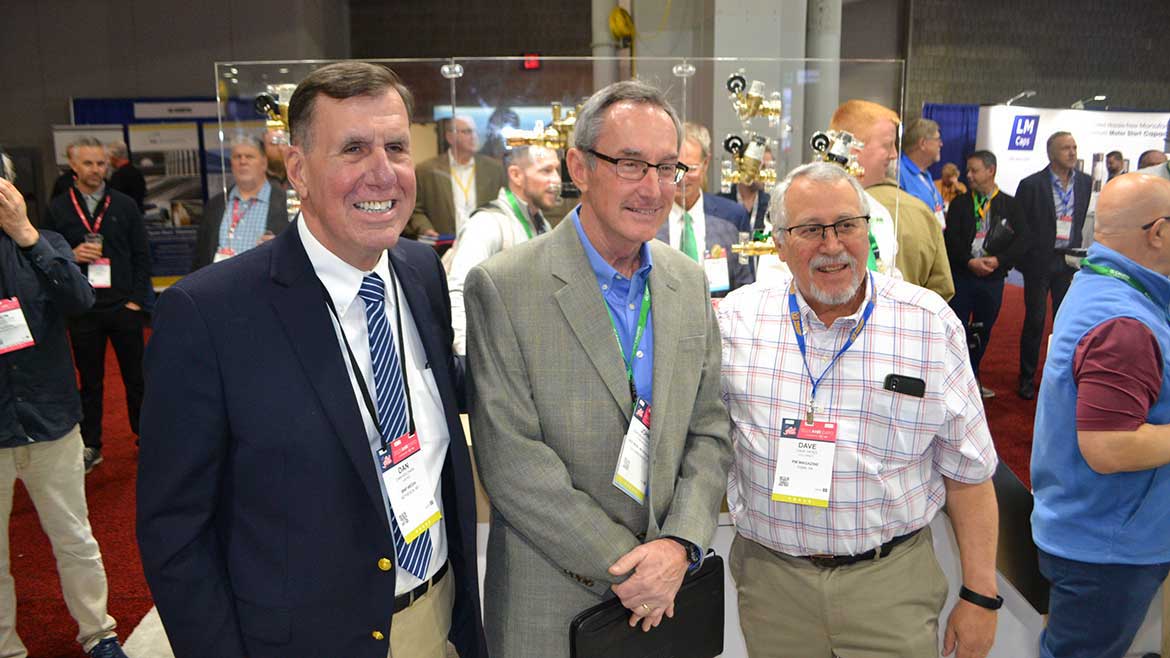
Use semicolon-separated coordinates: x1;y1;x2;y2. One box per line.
271;224;390;536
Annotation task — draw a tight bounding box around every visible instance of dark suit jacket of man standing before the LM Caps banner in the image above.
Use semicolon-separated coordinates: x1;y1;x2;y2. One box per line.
1016;167;1093;272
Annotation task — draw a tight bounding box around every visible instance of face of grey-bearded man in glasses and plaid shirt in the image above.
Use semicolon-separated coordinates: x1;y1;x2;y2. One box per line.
777;178;869;323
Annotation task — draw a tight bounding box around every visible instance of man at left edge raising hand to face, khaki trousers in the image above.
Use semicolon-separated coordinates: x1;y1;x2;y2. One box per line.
0;178;125;658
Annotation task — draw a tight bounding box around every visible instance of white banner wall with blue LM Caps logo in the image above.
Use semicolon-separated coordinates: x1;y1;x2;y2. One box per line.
976;105;1170;194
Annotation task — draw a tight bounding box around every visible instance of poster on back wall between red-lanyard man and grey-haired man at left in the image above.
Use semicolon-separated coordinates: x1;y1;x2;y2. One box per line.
130;123;204;276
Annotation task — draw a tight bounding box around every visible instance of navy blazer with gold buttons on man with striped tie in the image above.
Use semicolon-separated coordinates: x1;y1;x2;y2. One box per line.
138;225;487;658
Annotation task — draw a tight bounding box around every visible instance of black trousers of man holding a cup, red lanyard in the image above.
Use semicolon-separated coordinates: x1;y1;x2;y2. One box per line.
69;307;144;450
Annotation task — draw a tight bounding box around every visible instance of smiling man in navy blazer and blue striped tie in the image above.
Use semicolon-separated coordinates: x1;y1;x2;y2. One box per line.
138;62;487;658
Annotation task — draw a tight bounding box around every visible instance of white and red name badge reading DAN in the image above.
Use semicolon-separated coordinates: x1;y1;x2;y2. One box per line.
378;432;442;543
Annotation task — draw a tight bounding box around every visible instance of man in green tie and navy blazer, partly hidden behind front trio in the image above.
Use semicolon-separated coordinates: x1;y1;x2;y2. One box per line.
655;122;756;296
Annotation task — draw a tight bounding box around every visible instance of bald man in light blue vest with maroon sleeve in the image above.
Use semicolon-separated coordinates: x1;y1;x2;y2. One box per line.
1032;173;1170;658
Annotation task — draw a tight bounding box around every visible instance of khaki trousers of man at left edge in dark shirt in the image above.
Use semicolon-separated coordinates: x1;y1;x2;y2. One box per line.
0;425;115;658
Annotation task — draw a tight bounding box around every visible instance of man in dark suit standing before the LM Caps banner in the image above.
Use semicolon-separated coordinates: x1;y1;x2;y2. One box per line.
1016;131;1093;399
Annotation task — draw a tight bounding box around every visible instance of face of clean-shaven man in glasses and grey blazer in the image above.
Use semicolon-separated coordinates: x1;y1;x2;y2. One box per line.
569;101;679;255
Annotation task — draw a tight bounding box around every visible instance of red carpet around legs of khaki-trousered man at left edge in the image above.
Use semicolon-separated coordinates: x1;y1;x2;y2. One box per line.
8;339;153;658
